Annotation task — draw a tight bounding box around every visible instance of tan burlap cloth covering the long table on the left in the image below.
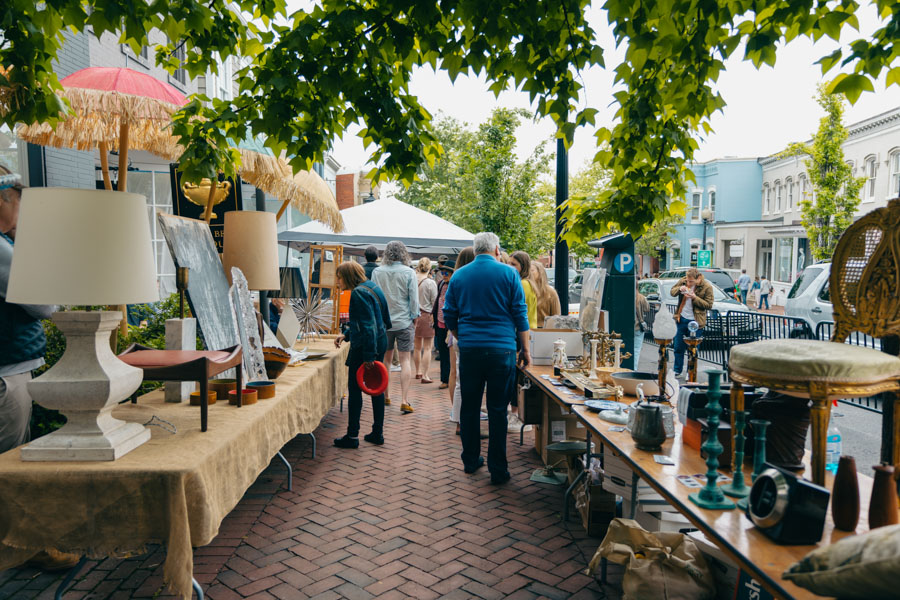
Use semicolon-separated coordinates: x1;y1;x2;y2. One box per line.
0;339;349;598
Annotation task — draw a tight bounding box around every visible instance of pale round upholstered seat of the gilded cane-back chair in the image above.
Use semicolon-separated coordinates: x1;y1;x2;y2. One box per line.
728;339;900;383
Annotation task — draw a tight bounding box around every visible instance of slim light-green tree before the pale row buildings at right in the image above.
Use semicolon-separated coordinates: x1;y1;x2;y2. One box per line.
781;86;865;260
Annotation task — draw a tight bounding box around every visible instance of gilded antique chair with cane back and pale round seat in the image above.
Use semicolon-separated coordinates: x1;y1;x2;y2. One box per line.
728;198;900;485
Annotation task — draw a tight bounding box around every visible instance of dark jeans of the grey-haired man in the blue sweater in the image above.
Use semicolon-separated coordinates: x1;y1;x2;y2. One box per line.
459;348;516;477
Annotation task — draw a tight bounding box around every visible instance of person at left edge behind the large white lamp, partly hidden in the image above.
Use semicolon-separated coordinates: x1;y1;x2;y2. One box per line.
0;165;80;571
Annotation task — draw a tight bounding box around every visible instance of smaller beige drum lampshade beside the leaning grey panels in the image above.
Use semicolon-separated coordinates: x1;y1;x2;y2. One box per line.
222;210;281;290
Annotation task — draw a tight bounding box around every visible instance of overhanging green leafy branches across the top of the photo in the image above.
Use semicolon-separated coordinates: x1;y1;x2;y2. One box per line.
0;0;900;241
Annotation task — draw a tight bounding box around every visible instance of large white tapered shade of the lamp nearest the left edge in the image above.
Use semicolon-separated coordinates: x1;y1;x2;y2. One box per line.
7;188;159;305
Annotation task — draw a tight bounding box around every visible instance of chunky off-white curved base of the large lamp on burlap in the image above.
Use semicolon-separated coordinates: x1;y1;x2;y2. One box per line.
21;311;150;461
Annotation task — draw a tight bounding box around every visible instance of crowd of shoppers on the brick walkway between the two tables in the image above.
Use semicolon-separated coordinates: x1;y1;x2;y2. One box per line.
334;232;560;484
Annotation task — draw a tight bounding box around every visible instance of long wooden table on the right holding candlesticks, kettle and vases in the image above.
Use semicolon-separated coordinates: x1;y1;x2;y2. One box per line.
524;366;872;599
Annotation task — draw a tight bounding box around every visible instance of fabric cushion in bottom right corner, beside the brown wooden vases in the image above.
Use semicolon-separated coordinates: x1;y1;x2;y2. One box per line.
782;525;900;600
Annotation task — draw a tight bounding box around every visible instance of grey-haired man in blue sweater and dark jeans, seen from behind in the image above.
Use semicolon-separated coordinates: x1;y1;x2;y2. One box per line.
444;232;531;484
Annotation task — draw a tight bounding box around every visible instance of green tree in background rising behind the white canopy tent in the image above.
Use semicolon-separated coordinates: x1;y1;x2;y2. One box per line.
398;108;554;255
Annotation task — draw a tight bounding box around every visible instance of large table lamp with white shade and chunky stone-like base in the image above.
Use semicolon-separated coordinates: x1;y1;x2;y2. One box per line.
6;188;159;461
